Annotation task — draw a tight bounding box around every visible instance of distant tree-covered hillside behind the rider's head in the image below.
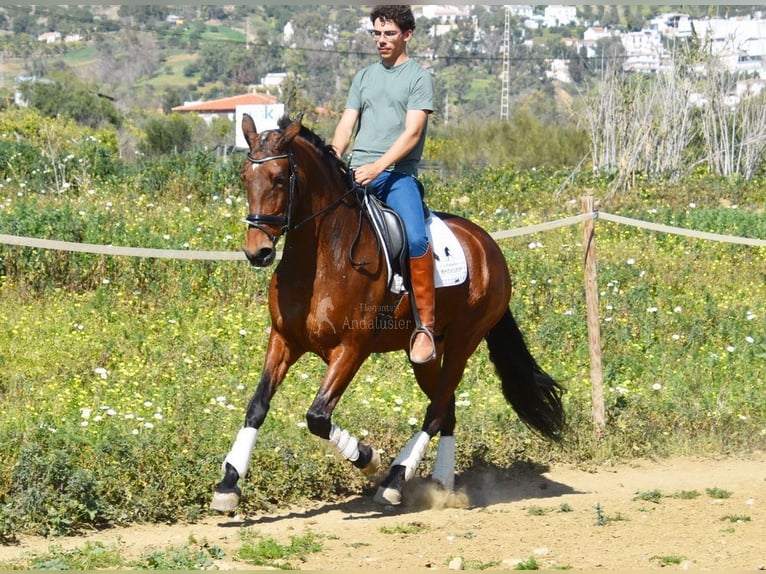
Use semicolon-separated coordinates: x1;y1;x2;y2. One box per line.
0;5;755;122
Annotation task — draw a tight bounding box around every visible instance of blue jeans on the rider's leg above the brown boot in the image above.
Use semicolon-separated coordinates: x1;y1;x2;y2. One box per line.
368;171;428;257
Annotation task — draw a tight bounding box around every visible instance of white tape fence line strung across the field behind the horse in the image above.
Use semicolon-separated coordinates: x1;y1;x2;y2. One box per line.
0;211;766;261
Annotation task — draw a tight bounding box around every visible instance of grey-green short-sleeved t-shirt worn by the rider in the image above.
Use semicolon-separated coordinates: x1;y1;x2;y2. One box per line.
346;59;434;176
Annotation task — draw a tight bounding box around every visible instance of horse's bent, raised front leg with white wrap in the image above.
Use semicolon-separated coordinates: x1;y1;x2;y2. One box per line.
306;351;380;474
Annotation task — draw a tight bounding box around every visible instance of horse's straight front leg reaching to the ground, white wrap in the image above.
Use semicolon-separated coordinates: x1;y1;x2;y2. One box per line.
210;331;296;512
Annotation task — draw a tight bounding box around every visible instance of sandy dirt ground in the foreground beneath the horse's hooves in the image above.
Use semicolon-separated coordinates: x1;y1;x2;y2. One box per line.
0;453;766;571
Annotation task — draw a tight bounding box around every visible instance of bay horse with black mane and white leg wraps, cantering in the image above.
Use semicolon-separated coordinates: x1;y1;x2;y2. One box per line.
210;115;564;512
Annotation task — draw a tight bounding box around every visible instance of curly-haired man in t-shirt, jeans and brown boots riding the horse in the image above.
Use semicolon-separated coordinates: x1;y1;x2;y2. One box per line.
332;5;436;364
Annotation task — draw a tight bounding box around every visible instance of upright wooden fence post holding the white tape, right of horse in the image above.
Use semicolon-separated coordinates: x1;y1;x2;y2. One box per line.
582;195;606;437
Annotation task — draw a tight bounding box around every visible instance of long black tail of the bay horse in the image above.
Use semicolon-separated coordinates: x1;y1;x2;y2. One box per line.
484;309;564;441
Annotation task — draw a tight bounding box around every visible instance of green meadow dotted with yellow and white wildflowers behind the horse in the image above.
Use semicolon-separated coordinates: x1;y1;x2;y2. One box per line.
0;109;766;540
